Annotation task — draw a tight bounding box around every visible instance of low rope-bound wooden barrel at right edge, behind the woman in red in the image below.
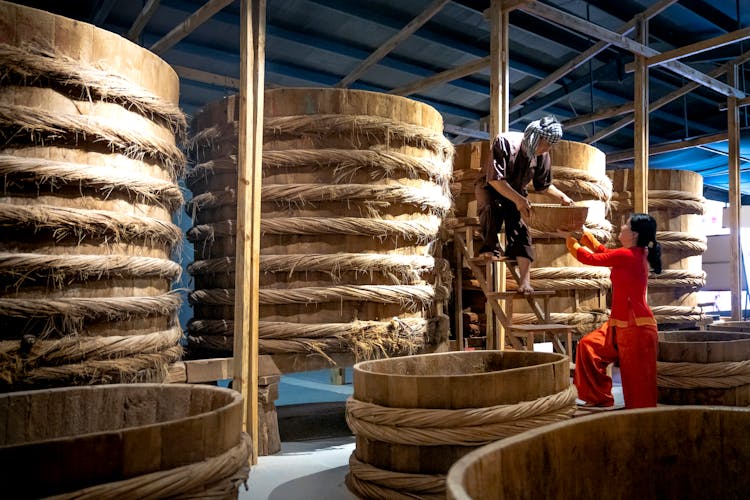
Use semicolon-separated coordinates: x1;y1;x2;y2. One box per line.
657;330;750;406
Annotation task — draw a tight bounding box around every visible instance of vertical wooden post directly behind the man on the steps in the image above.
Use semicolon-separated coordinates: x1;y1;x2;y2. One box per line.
494;0;513;349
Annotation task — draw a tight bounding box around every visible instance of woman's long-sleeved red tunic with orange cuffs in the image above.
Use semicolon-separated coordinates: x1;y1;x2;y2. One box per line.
576;245;656;327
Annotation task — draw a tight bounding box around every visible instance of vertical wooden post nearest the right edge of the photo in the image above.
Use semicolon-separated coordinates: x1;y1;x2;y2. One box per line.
727;64;742;321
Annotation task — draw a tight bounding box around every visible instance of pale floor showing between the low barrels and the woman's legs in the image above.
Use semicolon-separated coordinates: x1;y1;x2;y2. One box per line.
239;352;624;500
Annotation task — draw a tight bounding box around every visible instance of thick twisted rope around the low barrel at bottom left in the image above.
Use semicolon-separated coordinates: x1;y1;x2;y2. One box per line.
48;432;252;500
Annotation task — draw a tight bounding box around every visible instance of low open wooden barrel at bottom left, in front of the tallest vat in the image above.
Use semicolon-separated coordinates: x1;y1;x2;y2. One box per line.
0;384;251;498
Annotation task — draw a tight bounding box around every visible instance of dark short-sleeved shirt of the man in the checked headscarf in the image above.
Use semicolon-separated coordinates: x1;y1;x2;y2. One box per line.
484;132;552;196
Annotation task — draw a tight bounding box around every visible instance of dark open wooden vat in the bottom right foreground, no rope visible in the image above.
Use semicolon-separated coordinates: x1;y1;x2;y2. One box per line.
448;406;750;500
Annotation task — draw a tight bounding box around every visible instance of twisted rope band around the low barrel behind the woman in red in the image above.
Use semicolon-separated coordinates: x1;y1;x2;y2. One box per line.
656;360;750;389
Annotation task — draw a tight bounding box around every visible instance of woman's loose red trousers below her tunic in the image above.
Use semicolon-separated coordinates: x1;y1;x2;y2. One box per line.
573;322;657;408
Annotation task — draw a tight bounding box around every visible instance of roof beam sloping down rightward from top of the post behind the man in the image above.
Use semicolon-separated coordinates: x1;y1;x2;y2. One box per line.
519;2;745;99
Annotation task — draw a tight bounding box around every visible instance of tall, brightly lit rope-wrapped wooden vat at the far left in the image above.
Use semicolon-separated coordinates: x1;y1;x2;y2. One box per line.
0;2;185;391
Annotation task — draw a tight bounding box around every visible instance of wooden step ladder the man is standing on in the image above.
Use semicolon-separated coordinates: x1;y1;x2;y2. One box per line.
453;219;573;358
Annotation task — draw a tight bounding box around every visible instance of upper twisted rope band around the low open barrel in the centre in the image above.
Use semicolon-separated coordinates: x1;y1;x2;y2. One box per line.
346;385;577;446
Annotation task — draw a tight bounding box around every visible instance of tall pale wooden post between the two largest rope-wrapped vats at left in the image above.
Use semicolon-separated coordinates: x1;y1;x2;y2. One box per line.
232;0;266;464
